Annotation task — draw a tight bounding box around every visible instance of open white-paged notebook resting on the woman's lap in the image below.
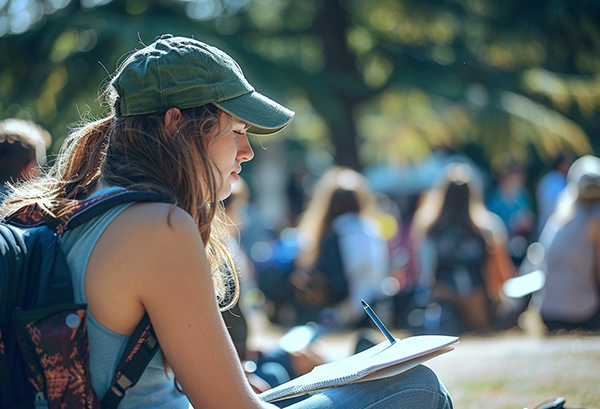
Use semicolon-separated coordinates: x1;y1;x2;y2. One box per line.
258;335;458;402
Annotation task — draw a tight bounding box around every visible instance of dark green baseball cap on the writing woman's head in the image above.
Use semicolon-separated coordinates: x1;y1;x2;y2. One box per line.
111;34;294;135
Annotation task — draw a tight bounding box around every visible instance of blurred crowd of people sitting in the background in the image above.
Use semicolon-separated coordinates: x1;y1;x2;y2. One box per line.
0;119;600;388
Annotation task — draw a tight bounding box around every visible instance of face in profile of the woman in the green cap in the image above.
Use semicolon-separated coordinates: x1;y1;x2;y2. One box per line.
208;115;254;200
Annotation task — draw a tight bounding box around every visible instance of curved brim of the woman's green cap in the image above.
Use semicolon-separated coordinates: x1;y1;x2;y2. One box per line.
214;92;295;135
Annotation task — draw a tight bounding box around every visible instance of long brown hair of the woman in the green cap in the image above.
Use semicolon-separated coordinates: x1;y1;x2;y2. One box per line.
0;105;239;310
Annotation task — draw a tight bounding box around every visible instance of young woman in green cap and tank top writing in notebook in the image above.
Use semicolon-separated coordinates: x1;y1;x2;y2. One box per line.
2;35;451;409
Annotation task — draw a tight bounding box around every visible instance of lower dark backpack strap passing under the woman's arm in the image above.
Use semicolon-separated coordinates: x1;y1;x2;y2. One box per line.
100;313;160;409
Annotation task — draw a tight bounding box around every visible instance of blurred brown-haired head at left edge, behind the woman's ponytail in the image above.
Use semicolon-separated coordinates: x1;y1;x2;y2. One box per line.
0;118;52;202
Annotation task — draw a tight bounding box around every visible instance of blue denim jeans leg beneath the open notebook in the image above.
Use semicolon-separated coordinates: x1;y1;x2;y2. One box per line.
274;365;453;409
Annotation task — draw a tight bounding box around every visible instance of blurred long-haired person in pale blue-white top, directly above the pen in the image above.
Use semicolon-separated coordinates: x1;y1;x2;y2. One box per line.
290;167;390;328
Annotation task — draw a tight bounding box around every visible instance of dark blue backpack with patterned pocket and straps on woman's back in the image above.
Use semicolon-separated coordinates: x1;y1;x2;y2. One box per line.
0;189;169;409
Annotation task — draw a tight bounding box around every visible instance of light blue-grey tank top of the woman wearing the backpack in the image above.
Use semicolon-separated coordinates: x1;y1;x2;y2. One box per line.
62;189;190;409
